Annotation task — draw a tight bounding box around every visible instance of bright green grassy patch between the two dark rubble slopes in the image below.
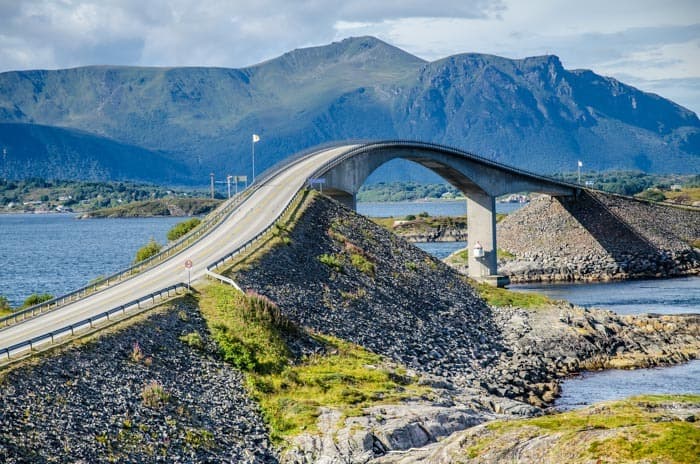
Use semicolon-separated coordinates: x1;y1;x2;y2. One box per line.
200;284;429;443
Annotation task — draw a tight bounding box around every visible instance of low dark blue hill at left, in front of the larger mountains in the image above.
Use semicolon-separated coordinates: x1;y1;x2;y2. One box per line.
0;123;191;185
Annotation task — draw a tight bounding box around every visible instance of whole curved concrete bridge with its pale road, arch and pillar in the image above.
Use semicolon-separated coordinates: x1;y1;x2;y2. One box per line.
0;141;578;358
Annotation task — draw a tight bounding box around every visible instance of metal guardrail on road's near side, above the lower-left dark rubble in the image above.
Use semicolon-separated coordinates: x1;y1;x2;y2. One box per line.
0;283;188;362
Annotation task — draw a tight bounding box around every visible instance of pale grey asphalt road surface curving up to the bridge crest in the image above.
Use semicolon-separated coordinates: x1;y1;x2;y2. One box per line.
0;146;351;349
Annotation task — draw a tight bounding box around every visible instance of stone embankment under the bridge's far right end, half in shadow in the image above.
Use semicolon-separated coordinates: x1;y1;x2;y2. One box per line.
498;191;700;282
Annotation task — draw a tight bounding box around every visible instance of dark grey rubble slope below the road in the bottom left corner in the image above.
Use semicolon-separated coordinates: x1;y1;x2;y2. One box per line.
0;299;276;464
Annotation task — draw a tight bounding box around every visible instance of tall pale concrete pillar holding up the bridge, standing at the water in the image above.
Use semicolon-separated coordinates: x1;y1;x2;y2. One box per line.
467;193;509;287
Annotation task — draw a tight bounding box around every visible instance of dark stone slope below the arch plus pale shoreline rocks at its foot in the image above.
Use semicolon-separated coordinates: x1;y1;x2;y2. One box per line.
230;191;700;462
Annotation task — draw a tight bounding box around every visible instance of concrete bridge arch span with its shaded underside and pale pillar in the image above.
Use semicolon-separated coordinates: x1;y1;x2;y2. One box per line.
312;141;579;285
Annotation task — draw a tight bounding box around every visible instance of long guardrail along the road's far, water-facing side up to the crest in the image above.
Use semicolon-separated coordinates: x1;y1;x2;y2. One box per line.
0;142;356;329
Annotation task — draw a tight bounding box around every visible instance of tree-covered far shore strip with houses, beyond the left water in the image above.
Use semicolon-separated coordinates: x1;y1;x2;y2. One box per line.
0;178;212;215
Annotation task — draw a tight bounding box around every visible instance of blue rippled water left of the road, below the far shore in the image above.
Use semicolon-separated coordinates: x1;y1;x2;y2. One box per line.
0;214;184;305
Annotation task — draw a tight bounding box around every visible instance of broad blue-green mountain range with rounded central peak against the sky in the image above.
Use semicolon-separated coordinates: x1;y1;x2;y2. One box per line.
0;37;700;183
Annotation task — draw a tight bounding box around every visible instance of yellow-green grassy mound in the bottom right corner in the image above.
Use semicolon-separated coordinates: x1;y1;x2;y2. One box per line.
465;395;700;463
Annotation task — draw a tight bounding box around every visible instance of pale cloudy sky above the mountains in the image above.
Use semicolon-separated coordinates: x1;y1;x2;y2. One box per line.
0;0;700;113
